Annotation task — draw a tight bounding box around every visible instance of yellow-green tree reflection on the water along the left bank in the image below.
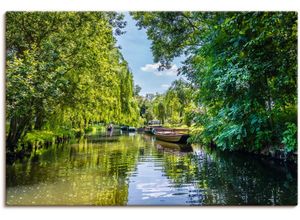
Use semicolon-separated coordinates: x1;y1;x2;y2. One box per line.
7;137;139;205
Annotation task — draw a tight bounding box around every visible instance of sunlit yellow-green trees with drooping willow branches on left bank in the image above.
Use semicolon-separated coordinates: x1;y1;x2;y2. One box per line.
6;12;139;152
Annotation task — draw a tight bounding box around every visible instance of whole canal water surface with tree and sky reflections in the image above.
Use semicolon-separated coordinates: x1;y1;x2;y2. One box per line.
6;133;297;206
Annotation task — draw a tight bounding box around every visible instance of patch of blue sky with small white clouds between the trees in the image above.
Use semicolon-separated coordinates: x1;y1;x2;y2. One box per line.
117;13;181;95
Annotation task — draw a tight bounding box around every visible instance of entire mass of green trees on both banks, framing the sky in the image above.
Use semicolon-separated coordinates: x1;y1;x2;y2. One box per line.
6;12;297;157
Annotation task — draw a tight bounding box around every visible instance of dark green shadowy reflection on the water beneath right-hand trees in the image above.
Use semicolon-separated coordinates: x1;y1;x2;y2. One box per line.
189;147;297;205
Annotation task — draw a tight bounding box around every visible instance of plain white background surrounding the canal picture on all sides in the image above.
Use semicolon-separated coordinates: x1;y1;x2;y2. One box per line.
0;0;300;220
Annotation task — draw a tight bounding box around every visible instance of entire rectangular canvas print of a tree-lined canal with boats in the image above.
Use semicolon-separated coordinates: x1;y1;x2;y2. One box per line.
5;11;298;206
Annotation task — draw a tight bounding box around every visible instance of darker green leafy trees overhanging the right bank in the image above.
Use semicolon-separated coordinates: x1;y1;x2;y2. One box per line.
132;12;297;152
